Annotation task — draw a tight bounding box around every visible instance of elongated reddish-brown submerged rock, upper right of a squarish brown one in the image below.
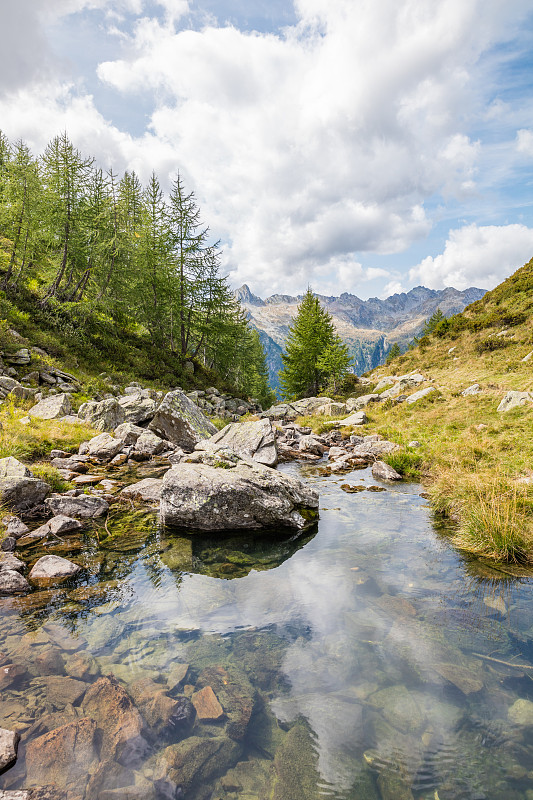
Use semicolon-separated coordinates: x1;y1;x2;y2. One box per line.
83;676;149;766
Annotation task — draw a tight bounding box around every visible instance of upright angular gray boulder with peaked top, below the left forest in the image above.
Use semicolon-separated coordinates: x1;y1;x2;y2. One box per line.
148;389;217;451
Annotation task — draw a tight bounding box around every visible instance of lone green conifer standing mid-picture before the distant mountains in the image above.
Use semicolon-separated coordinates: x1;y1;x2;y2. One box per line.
279;288;339;399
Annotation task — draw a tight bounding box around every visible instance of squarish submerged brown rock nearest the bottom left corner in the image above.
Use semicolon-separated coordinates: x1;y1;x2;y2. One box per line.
26;718;98;795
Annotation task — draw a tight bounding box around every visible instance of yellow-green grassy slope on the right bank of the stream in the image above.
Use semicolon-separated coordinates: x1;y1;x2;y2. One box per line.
308;259;533;561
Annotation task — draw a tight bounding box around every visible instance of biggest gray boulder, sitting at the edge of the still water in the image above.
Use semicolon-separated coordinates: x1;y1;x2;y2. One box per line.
160;451;318;531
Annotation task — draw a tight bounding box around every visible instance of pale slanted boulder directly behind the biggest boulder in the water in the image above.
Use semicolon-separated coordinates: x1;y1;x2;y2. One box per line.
196;419;278;467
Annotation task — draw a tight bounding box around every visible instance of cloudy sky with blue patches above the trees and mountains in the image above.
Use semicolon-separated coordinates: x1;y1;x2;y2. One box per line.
0;0;533;299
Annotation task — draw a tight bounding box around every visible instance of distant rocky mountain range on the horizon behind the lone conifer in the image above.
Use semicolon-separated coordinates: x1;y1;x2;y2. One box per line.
236;284;486;389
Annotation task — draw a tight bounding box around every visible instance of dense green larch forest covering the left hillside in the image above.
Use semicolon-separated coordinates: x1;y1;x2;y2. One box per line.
0;132;271;402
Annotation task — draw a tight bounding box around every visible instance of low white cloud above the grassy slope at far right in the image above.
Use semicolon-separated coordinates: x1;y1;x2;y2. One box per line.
409;224;533;290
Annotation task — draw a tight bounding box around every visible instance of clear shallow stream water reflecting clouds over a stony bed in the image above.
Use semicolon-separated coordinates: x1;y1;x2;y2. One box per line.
0;465;533;800
